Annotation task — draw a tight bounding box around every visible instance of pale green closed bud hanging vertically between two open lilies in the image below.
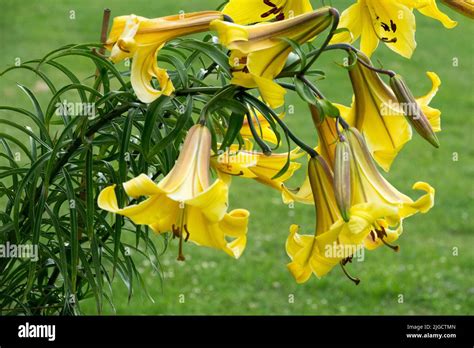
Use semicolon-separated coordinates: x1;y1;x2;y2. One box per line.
334;141;351;222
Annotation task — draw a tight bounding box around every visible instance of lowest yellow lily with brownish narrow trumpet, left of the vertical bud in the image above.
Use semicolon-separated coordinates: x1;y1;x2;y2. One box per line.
286;157;384;283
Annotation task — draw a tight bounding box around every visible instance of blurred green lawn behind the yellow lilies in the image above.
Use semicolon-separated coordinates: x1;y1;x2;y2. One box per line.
0;0;474;315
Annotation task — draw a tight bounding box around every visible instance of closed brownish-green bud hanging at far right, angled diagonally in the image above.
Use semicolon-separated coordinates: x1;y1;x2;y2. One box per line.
390;75;439;147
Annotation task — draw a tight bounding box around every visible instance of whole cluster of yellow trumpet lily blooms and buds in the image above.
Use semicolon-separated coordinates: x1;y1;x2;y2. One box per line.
98;0;464;283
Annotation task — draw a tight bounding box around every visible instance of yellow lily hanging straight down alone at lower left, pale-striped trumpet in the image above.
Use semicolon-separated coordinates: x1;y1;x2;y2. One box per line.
98;125;249;260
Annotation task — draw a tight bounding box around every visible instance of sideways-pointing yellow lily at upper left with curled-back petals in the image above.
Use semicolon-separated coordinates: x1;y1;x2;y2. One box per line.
105;11;223;103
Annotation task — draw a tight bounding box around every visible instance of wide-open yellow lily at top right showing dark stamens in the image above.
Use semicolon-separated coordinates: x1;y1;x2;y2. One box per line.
331;0;457;58
